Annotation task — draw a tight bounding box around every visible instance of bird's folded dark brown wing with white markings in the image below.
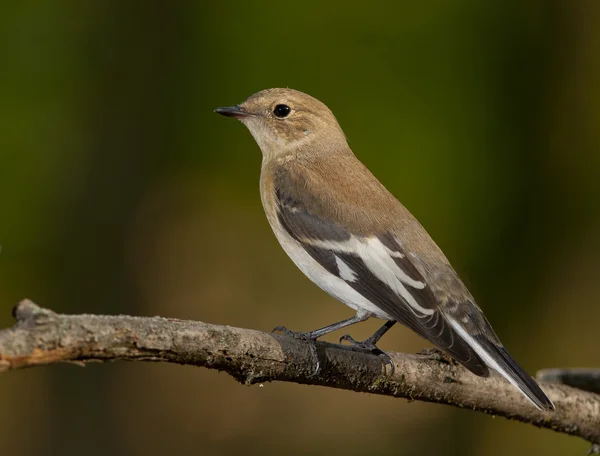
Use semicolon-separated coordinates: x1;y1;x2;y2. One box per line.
275;169;490;376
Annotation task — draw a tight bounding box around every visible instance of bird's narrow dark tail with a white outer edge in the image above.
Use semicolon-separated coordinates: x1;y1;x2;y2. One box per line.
450;320;554;411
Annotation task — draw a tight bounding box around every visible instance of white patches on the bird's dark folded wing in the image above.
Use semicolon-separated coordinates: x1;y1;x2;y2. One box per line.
302;236;435;318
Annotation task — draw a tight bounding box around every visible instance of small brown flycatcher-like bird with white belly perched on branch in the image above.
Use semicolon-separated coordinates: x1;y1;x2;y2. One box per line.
214;88;554;411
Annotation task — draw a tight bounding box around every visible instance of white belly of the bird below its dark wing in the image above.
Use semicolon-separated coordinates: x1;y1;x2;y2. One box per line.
273;224;393;320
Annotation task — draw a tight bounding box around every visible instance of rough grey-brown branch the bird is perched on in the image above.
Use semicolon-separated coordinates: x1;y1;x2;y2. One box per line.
0;300;600;444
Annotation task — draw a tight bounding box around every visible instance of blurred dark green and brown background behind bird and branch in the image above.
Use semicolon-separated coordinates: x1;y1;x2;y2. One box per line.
0;0;600;456
